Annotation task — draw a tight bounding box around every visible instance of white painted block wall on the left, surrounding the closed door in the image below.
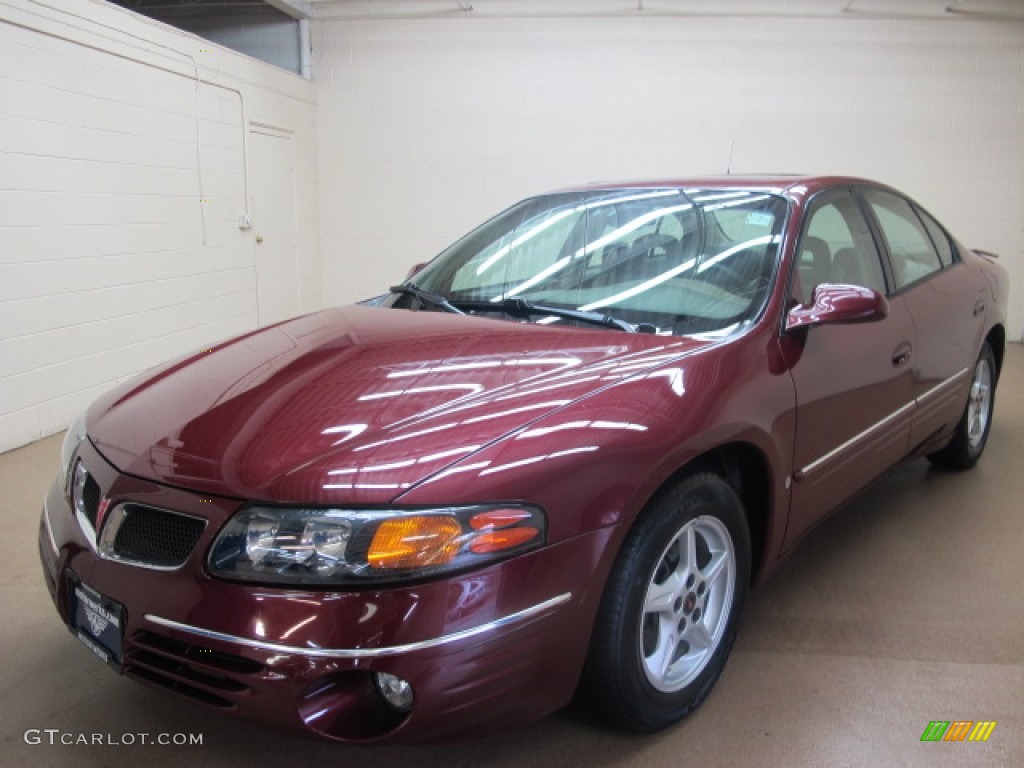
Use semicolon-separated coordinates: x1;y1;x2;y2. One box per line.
0;0;321;451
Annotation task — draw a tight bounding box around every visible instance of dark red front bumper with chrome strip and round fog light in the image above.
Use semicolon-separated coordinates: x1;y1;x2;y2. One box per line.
39;444;615;742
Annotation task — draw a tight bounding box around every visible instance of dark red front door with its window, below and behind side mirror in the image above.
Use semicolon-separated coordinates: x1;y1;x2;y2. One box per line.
785;188;915;546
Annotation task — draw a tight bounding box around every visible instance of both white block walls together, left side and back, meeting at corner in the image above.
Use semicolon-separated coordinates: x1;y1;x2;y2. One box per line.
0;0;1024;451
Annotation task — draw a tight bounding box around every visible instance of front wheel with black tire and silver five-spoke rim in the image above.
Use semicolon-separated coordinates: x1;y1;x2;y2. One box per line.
579;472;751;733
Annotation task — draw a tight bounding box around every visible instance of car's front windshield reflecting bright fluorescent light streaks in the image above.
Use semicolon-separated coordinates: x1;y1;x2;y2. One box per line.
395;188;786;335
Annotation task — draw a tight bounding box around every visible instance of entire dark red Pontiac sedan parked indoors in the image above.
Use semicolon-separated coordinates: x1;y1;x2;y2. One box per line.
39;177;1008;742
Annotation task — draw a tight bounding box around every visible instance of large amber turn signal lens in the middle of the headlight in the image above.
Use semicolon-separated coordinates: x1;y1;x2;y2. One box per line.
367;515;462;568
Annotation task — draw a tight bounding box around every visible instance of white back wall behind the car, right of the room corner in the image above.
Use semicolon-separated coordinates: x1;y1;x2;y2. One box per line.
314;6;1024;338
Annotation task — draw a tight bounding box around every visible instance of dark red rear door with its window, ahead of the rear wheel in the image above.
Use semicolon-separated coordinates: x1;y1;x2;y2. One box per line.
860;187;985;447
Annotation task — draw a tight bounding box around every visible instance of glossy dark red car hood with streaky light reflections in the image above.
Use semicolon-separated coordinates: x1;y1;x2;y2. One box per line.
87;306;708;504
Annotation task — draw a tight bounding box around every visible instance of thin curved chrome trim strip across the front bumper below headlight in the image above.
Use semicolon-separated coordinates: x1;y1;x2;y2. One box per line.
142;592;572;658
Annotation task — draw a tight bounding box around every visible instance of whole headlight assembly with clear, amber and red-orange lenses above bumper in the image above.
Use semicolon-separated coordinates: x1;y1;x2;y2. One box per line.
209;504;547;586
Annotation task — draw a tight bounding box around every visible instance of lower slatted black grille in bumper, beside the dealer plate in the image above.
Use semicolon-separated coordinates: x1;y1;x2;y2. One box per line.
125;631;263;709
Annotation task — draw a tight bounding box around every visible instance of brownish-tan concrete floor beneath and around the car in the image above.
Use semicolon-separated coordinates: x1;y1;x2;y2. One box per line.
0;345;1024;768
